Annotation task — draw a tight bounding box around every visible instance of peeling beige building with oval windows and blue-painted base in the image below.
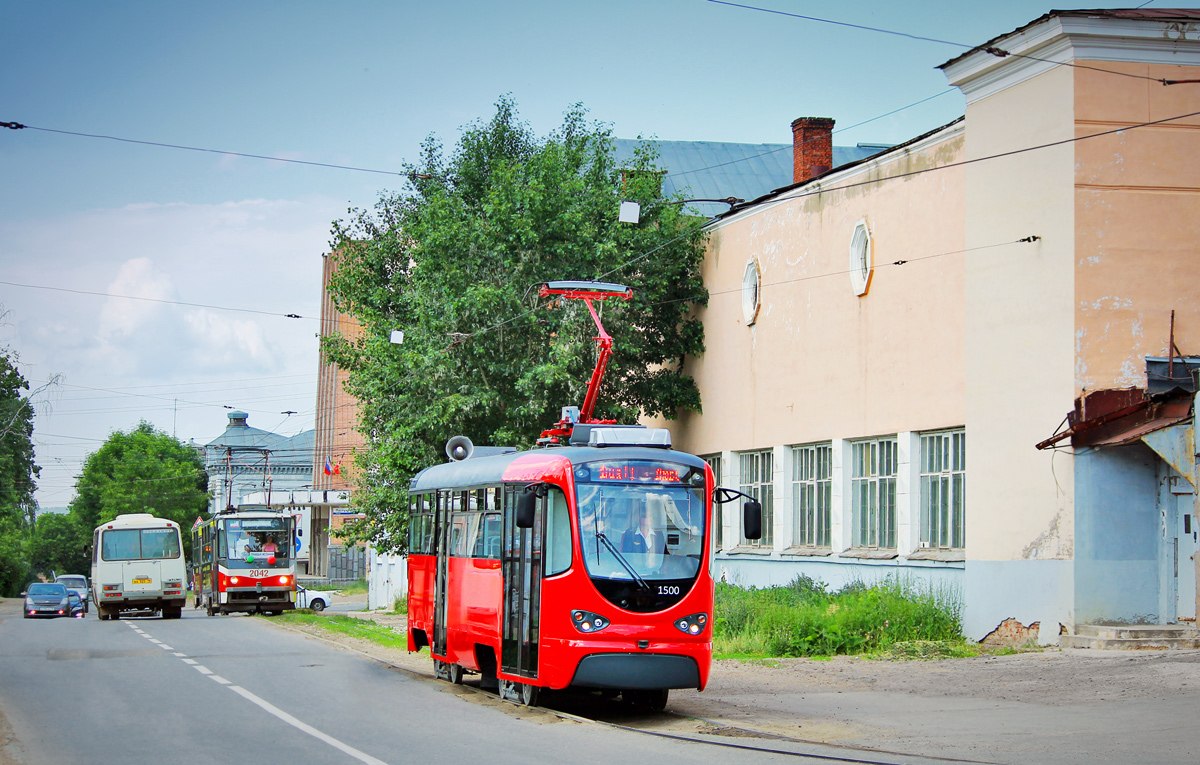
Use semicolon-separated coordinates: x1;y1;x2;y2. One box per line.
652;8;1200;643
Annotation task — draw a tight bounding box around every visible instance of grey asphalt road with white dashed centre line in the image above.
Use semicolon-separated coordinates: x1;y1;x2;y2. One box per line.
0;601;945;765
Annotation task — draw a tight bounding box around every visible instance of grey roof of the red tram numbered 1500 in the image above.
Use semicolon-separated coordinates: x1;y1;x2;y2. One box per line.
408;446;704;493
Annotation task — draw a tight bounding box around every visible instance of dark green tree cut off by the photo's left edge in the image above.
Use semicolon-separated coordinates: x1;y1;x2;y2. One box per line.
0;350;40;596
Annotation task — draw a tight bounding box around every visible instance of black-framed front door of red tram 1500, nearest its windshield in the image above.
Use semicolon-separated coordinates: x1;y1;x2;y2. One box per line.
500;486;546;677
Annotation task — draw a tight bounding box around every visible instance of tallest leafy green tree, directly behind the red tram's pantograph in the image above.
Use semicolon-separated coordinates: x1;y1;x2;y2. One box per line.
323;97;708;550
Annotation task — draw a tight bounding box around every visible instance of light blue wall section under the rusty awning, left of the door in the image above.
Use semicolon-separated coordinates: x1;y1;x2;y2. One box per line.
1075;442;1163;624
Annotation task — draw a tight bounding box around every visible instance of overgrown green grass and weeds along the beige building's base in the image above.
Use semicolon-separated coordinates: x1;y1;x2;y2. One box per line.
713;577;964;656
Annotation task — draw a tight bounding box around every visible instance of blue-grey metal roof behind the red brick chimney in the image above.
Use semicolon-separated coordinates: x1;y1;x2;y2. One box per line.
614;138;887;216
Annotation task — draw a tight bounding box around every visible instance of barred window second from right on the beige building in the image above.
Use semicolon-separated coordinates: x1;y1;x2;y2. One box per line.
850;438;896;548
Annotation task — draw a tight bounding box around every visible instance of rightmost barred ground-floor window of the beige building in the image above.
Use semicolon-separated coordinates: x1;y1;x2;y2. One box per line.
920;429;967;549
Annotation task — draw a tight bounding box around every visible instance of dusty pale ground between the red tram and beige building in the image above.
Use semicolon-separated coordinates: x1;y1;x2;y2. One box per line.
288;612;1200;764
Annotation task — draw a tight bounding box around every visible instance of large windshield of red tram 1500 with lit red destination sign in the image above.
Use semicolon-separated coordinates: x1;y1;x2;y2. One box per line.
575;460;706;584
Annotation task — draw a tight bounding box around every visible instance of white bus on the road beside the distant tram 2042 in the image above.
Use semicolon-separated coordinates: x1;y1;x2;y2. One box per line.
91;513;187;619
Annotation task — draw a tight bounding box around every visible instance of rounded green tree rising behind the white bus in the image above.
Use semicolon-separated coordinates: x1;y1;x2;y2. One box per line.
70;422;209;556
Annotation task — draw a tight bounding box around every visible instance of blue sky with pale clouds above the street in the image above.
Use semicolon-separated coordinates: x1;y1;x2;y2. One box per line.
0;0;1200;515
